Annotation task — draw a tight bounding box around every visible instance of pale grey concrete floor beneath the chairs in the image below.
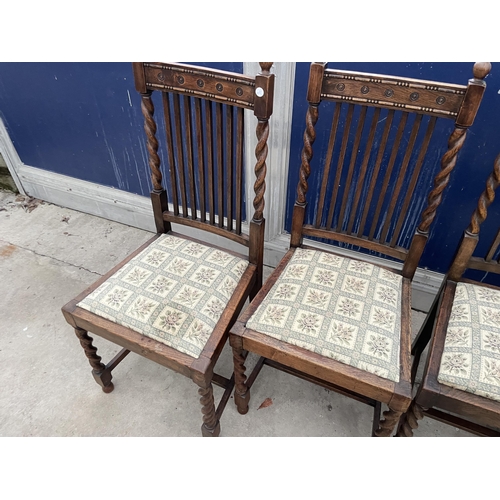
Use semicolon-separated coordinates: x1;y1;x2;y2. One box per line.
0;192;470;437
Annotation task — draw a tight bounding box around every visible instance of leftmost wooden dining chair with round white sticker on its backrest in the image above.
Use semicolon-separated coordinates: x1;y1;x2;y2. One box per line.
62;63;274;436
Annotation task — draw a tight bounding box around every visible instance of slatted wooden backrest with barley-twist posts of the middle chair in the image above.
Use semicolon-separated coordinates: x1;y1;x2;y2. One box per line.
291;63;491;279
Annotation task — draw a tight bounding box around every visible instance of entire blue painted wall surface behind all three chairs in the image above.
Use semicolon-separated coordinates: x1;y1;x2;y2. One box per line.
0;63;500;278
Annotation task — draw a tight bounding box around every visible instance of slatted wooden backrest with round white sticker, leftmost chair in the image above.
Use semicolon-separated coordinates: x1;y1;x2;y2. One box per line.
132;63;274;266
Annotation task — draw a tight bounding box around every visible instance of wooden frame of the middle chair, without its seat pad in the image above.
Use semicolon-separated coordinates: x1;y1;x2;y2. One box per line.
230;63;490;436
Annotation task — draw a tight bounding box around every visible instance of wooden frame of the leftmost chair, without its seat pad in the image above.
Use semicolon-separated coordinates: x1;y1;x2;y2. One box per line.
62;63;274;436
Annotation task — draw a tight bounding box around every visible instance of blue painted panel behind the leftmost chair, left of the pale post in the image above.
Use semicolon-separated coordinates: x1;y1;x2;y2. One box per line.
0;62;243;196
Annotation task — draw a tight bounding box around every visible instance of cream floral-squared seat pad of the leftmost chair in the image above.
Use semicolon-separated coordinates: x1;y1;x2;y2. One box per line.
78;235;248;358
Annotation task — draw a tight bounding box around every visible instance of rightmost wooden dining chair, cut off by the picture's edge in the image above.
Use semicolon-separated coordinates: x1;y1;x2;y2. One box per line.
397;155;500;437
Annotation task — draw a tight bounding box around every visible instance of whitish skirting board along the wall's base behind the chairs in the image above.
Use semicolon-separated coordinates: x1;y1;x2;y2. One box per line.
17;165;444;311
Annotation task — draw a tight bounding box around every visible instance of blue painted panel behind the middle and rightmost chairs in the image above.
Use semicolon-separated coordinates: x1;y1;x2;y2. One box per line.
286;63;500;272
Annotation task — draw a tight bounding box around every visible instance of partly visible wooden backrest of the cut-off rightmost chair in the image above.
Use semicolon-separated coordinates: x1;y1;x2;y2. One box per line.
447;154;500;281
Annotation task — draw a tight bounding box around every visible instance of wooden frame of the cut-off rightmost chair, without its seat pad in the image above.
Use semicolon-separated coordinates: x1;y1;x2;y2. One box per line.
397;155;500;437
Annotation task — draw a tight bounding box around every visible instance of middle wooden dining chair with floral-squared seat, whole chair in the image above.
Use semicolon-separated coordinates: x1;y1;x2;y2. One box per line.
230;63;490;436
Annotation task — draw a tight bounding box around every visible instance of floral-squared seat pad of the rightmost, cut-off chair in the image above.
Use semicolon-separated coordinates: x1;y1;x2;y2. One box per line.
438;283;500;401
